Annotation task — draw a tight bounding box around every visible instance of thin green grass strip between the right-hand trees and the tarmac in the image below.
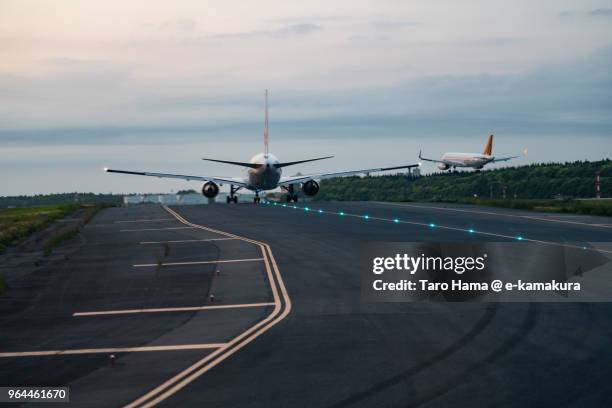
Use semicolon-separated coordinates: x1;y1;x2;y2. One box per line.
445;198;612;217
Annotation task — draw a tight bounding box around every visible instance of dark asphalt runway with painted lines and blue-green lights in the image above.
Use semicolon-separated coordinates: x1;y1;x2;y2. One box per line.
0;202;612;407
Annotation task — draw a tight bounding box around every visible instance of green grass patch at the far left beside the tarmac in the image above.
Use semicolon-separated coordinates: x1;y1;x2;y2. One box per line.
0;204;80;252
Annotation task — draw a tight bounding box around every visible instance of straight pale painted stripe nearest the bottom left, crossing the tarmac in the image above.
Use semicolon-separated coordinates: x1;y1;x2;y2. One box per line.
0;343;227;358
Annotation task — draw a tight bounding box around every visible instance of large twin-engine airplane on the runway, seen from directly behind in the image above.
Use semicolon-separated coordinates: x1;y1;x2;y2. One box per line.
104;89;420;204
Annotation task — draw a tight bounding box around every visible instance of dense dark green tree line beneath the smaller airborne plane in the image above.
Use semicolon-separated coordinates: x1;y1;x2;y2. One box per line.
316;159;612;201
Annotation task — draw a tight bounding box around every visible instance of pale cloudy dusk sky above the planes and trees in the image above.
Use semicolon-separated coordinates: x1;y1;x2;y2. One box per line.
0;0;612;196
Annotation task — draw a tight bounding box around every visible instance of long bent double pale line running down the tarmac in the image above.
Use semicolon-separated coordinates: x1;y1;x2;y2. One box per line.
125;205;291;408
